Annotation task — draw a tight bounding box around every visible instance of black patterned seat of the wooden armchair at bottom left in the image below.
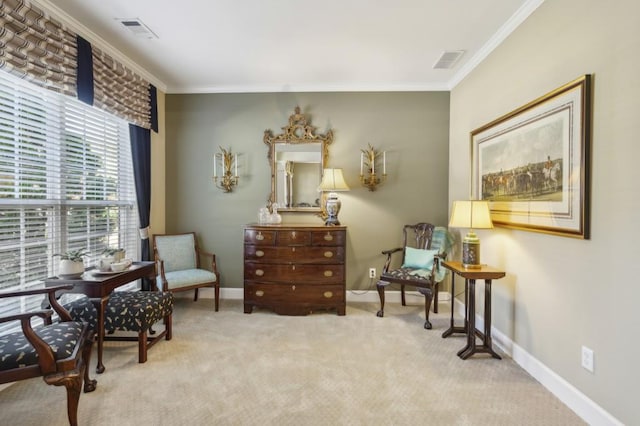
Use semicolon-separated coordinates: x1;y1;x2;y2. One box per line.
0;321;84;370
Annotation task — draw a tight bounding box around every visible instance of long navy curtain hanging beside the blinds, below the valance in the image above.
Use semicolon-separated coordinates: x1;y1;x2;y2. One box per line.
129;124;151;290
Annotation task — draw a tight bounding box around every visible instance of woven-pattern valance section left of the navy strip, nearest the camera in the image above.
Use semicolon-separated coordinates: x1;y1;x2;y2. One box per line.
0;0;77;97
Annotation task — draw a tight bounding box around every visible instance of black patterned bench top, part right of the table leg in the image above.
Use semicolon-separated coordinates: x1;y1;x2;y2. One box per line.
104;291;173;333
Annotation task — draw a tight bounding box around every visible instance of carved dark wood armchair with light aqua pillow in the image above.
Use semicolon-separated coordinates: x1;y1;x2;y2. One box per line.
376;222;453;329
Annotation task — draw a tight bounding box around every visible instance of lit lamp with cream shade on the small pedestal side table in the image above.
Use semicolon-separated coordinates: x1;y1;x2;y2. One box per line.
449;200;493;268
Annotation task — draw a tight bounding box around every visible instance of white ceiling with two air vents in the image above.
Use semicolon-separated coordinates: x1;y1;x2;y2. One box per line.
40;0;544;93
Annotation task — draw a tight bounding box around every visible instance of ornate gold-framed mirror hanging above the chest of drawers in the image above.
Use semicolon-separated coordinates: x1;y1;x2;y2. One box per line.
264;106;333;213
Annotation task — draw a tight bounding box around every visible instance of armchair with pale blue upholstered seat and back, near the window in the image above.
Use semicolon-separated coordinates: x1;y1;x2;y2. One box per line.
153;232;220;311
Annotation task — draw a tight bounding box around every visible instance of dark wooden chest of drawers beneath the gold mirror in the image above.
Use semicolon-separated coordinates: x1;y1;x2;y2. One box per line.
244;224;347;315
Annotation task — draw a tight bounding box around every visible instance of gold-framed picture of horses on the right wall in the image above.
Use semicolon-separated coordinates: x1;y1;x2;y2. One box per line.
471;75;591;239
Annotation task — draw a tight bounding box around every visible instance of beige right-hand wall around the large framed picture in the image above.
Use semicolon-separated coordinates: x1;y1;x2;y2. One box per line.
449;0;640;424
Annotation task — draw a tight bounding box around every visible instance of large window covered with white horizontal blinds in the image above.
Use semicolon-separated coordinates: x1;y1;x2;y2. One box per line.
0;71;139;331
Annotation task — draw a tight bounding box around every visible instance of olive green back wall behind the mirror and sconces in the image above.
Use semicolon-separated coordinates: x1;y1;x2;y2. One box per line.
166;92;449;294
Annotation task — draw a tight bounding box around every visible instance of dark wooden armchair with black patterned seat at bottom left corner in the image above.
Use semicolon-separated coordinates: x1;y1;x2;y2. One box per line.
0;285;96;425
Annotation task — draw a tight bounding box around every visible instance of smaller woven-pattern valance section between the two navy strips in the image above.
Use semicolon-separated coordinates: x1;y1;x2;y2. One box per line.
92;46;151;129
